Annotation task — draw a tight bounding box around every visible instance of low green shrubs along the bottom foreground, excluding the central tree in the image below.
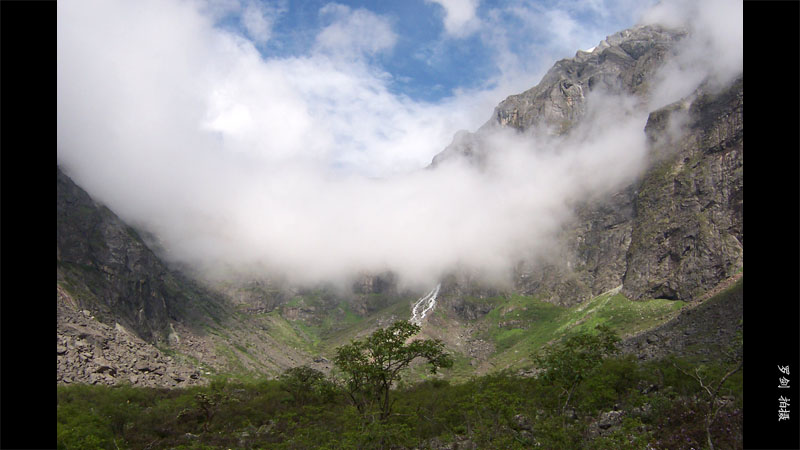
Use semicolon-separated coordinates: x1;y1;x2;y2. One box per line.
56;348;743;450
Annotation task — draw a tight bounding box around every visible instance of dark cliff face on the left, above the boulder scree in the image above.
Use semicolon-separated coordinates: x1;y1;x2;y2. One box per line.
57;168;228;344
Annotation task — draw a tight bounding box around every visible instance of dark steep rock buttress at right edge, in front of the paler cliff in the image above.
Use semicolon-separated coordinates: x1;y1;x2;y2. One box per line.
622;78;744;300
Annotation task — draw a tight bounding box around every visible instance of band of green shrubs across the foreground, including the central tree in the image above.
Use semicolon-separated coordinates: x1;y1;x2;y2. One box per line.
56;324;743;450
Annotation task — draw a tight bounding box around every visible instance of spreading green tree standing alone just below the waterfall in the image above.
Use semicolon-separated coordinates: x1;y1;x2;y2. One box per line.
333;321;453;421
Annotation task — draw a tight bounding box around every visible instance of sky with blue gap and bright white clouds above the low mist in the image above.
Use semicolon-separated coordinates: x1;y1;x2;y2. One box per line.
58;0;654;177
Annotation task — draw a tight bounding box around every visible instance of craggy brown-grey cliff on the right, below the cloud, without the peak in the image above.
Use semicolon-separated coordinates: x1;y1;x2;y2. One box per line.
517;78;744;305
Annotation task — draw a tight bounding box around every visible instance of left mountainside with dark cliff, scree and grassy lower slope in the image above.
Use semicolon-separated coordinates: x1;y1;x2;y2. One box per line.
56;167;340;387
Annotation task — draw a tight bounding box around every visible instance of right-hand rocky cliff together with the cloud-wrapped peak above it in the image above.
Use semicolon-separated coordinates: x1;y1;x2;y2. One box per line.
431;26;744;306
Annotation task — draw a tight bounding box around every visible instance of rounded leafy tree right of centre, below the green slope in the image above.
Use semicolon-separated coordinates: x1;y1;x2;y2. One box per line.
533;325;619;414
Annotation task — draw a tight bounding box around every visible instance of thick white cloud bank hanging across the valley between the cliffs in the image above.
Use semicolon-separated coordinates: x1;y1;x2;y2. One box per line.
57;0;742;284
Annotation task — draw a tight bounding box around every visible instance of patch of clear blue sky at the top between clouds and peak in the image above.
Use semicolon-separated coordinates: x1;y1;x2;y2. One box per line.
203;0;653;102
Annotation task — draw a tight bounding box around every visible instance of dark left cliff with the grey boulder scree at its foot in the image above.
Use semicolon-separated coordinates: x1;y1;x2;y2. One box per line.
56;168;244;386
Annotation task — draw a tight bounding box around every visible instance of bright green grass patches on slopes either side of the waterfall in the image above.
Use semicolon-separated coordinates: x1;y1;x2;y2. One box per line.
267;284;685;381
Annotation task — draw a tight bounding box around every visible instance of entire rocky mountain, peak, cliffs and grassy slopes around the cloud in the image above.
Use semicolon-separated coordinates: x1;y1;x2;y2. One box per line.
57;22;744;386
